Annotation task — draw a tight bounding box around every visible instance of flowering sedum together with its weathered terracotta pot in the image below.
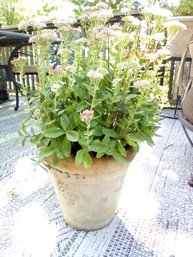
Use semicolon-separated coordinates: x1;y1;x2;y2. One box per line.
13;3;185;230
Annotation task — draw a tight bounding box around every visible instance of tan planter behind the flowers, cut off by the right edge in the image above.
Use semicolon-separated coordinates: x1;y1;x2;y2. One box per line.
170;16;193;57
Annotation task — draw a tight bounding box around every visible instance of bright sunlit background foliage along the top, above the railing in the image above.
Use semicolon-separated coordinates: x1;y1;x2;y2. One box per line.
0;0;184;25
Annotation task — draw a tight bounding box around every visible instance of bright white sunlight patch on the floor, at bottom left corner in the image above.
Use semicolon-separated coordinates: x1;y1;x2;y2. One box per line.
13;202;57;257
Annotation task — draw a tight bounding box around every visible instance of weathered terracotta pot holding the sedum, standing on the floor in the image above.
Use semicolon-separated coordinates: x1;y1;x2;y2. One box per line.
47;148;135;231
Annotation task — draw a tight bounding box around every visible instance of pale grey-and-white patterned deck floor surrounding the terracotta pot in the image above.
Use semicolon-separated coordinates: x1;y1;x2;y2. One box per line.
0;101;193;257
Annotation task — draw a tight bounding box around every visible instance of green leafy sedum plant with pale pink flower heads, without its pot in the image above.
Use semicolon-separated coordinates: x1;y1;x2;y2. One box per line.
13;3;185;168
